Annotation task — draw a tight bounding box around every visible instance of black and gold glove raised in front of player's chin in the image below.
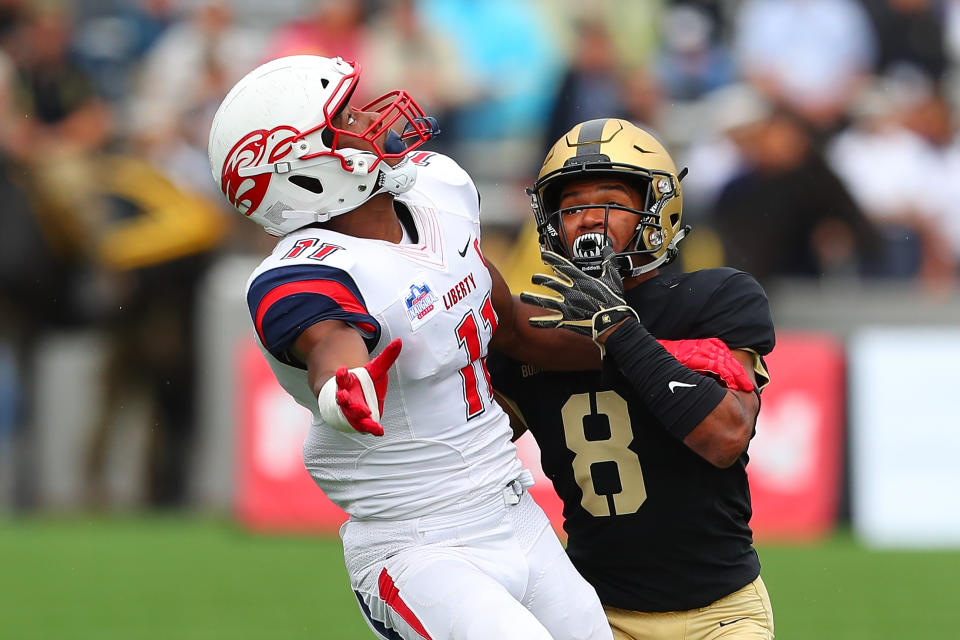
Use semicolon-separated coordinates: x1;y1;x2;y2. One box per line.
520;247;640;350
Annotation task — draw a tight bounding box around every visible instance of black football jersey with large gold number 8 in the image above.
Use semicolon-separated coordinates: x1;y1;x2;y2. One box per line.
489;268;774;611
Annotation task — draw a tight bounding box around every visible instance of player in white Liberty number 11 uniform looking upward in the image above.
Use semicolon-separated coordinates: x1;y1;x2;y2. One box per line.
209;56;612;640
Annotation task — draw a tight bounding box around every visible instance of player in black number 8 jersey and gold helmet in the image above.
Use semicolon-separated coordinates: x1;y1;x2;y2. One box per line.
490;118;774;640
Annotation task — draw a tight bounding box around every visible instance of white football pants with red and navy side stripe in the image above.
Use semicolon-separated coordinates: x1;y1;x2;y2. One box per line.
340;493;613;640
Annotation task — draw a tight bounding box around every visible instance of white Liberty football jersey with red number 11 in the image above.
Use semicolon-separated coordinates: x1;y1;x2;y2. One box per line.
247;152;525;519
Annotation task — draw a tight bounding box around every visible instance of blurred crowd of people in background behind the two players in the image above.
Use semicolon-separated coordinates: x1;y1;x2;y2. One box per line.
0;0;960;507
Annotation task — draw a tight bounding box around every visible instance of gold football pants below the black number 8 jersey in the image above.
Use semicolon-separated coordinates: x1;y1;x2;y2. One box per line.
604;577;773;640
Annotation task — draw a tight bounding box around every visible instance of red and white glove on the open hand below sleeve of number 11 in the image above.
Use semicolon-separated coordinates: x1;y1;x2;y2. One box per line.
320;338;403;436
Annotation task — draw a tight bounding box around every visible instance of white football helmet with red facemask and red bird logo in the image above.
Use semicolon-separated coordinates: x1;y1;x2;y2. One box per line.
208;56;439;236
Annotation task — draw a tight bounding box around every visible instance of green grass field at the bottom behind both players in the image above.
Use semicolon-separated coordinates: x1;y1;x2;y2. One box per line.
0;517;960;640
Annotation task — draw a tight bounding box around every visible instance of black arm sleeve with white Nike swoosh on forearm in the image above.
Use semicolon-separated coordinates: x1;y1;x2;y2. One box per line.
605;318;727;440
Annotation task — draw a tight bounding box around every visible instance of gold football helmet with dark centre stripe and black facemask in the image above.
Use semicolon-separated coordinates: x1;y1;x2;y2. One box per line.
527;118;690;277
